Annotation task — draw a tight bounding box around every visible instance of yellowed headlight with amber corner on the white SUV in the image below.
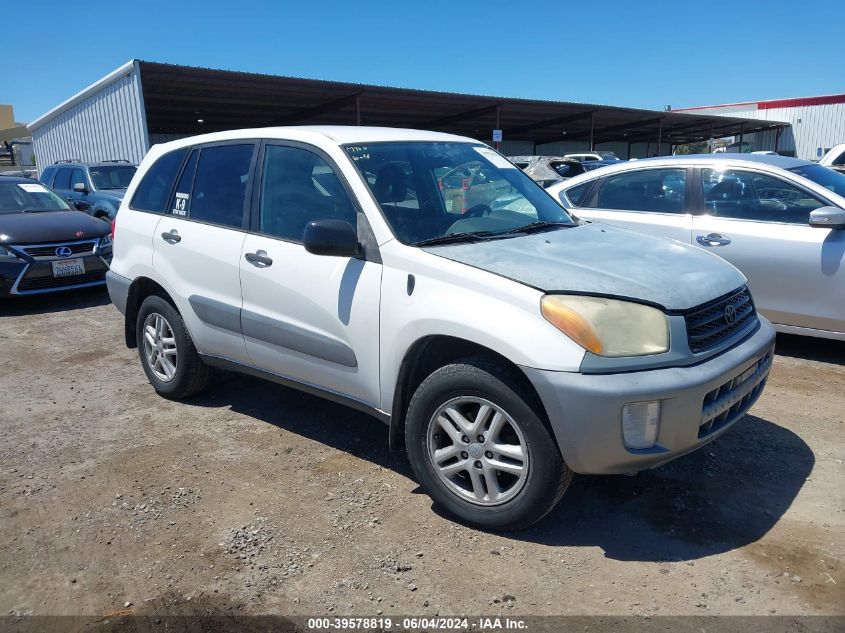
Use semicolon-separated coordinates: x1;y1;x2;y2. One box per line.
540;295;669;356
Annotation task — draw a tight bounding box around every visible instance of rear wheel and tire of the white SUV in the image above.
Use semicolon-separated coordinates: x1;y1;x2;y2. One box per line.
135;295;212;400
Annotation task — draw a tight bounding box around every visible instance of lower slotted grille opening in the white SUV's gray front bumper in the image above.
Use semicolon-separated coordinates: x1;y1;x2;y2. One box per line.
698;348;774;439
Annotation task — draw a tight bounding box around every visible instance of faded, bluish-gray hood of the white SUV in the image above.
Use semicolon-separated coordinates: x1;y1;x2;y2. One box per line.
425;224;746;310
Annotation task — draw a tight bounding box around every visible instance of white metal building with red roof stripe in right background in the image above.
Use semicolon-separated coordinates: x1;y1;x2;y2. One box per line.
673;94;845;160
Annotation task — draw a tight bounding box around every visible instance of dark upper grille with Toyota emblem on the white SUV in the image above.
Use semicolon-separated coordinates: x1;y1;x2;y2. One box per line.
685;288;757;354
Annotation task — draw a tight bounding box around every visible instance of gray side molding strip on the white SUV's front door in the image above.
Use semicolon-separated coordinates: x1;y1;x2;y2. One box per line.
241;310;358;367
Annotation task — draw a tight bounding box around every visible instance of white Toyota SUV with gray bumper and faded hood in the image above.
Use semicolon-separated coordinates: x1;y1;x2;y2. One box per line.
108;127;774;529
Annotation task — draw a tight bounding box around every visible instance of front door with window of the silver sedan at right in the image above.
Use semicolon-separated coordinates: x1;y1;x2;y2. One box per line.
693;168;845;332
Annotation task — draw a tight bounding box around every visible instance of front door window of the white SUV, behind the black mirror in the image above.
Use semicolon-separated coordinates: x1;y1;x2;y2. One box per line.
259;145;356;242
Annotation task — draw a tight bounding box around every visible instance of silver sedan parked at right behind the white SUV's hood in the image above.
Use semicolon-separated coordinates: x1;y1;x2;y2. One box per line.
548;153;845;340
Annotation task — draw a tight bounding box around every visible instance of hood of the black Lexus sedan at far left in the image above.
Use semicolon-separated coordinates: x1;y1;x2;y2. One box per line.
0;210;110;244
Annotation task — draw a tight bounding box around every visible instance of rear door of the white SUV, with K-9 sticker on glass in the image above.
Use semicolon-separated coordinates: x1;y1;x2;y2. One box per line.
152;141;257;362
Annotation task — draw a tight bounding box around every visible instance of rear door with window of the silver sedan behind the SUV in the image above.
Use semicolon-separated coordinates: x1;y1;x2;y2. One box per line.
574;166;692;243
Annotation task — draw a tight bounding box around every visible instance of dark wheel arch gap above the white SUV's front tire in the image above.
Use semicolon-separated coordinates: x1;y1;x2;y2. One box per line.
390;334;554;448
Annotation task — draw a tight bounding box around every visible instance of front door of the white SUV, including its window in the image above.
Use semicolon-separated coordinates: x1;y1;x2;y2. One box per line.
240;142;382;407
